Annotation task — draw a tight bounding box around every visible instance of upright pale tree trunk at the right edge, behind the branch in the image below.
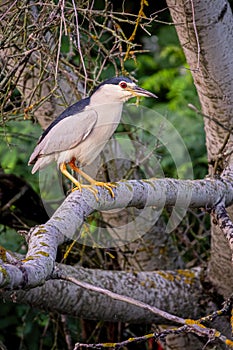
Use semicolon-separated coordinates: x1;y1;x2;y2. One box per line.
167;0;233;296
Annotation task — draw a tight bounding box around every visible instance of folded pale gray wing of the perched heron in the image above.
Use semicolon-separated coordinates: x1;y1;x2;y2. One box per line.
29;109;97;164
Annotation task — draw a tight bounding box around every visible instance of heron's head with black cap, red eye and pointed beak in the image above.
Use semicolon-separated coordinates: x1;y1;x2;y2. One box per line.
91;77;157;104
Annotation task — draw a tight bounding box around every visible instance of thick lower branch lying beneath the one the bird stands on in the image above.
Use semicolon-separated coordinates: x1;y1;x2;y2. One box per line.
1;264;204;323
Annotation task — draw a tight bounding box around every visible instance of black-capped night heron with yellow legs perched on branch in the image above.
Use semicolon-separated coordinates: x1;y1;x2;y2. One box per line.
28;77;157;197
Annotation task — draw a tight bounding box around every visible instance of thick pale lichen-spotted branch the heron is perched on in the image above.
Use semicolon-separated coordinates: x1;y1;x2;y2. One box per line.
0;177;233;289
